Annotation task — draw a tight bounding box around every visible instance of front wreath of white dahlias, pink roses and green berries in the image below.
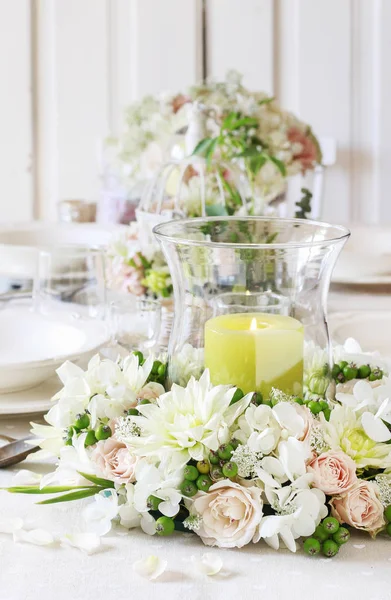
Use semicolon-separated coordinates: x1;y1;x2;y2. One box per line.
9;340;391;557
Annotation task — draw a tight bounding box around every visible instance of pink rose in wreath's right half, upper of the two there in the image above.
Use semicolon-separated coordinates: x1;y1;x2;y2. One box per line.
307;451;358;496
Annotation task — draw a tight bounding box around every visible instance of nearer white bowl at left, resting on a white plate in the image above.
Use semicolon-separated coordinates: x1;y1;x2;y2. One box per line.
0;303;109;393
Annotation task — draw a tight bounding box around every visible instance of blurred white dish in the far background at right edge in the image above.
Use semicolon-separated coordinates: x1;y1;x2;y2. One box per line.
332;225;391;285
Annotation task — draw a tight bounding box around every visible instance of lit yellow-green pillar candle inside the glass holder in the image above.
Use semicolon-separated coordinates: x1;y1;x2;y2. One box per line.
205;313;304;397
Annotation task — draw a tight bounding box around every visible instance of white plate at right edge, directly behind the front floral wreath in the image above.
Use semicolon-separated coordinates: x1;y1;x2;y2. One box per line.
329;310;391;360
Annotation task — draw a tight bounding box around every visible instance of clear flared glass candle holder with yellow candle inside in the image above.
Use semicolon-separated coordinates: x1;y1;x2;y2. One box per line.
154;217;349;395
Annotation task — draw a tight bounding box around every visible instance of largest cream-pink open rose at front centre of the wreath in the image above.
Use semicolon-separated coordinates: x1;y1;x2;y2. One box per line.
191;480;263;548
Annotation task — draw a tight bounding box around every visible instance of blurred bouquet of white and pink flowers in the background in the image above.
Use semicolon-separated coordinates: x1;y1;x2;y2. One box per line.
108;72;321;216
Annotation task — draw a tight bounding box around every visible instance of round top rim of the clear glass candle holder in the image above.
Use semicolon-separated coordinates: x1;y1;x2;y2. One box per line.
152;216;350;250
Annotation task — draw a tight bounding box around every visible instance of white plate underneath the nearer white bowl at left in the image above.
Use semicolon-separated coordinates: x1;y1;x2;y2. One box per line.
0;375;62;417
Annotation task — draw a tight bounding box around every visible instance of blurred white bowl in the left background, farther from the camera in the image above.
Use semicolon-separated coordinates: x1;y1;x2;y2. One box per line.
0;221;126;279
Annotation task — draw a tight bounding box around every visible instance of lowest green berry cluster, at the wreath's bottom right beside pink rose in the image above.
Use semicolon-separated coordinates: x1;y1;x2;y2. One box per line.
303;517;350;558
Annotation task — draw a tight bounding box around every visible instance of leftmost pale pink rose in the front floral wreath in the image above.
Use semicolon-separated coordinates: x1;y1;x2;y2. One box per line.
91;438;139;483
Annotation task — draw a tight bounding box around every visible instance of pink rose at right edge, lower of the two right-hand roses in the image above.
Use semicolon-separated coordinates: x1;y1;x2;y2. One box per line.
330;480;386;536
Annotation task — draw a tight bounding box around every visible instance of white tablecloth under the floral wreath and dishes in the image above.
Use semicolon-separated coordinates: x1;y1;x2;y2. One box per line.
0;290;391;600
